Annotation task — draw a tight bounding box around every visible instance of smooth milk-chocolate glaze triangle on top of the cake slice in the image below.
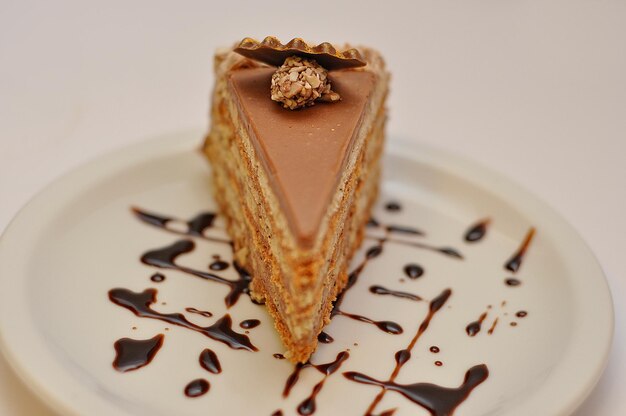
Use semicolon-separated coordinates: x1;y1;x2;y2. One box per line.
229;68;375;247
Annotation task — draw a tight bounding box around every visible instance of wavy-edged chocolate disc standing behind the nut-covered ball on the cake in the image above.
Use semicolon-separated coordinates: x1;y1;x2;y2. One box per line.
235;36;367;69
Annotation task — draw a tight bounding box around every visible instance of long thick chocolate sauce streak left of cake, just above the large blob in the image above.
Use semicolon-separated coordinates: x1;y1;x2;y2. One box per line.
109;288;257;351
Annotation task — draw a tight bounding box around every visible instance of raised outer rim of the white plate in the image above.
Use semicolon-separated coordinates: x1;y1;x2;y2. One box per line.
0;129;614;416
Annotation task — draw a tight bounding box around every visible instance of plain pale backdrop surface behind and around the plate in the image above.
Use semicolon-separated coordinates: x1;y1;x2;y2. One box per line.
0;0;626;416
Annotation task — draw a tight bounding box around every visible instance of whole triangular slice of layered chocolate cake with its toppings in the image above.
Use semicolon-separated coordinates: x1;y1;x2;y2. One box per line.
204;37;389;362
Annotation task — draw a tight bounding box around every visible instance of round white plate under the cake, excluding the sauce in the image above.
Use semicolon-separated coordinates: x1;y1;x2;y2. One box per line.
0;133;613;416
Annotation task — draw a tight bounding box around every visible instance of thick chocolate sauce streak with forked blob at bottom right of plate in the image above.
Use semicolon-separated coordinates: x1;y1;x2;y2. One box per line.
344;364;489;416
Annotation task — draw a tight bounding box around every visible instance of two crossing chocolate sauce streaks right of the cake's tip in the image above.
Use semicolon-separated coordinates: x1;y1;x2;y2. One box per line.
344;289;480;416
